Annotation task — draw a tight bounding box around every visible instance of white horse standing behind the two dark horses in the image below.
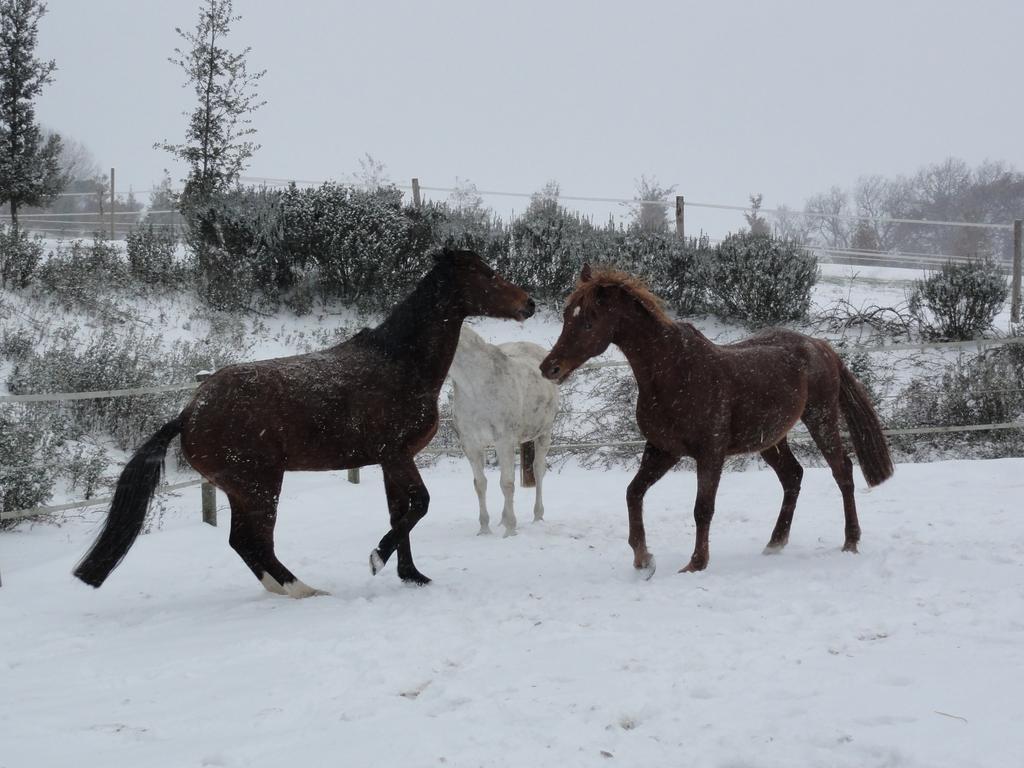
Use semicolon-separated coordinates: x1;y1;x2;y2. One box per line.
449;325;558;536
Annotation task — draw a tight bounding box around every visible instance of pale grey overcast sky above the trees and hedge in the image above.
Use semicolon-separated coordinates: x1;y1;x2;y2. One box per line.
38;0;1024;233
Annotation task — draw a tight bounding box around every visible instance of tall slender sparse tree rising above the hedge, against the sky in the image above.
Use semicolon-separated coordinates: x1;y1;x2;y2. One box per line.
155;0;266;215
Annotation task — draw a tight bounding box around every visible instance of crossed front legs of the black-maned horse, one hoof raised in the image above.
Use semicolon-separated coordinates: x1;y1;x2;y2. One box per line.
370;457;430;586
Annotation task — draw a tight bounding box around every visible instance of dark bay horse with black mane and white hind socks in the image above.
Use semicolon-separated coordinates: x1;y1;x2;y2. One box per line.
75;251;535;597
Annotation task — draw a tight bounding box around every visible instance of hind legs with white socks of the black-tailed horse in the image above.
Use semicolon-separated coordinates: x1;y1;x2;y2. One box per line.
226;474;328;598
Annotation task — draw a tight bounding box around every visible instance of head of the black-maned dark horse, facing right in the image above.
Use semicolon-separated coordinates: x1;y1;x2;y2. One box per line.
434;248;537;321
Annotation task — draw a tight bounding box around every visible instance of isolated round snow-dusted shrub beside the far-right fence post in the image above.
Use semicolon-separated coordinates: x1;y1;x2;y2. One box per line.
908;257;1009;340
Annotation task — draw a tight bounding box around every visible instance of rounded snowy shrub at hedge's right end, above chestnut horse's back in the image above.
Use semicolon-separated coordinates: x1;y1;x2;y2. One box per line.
707;232;818;326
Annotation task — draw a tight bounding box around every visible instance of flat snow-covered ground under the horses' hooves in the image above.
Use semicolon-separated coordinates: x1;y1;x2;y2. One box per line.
0;459;1024;768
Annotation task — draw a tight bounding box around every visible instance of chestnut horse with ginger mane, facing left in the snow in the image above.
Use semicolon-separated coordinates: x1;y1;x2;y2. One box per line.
541;266;893;577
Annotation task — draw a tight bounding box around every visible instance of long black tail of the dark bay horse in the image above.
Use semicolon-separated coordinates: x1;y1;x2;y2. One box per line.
75;419;181;588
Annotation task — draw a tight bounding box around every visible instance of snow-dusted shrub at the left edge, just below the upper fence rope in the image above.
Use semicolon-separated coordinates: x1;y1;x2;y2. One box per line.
0;406;55;530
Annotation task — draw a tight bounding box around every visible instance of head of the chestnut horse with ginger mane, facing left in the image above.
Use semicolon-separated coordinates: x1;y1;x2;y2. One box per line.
541;264;622;384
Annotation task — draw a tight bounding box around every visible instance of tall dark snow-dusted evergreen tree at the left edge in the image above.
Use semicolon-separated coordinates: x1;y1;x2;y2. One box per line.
0;0;67;227
